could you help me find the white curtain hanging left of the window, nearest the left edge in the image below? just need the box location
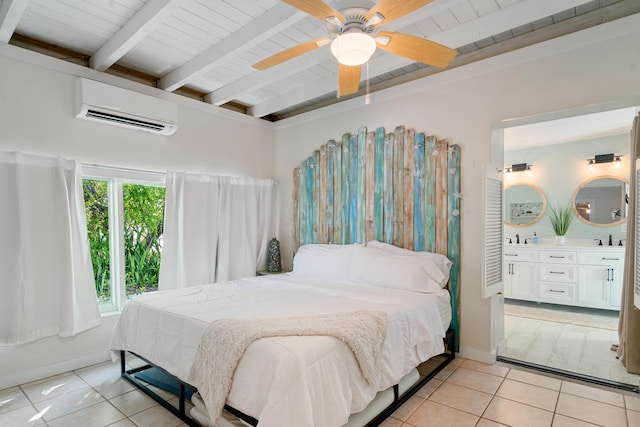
[0,152,100,345]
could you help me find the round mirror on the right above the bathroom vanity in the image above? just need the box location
[573,176,629,226]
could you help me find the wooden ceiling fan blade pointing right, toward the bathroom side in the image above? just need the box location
[377,31,458,68]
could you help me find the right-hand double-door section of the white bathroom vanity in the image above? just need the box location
[578,249,624,310]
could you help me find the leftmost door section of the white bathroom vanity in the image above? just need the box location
[503,248,538,301]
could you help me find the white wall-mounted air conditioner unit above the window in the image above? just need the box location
[75,77,178,135]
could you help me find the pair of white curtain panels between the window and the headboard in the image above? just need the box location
[158,172,273,290]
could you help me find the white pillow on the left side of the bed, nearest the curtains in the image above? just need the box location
[292,244,363,282]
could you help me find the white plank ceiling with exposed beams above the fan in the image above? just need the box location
[0,0,640,120]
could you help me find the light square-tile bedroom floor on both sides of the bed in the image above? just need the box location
[0,358,640,427]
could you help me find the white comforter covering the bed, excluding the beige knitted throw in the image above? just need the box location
[111,274,451,427]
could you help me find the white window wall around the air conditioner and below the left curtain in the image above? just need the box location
[0,44,277,389]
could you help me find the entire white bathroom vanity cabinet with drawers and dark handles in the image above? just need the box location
[503,245,624,310]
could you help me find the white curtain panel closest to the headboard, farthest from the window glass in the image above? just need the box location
[216,178,273,282]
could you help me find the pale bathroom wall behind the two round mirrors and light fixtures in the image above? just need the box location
[504,133,631,244]
